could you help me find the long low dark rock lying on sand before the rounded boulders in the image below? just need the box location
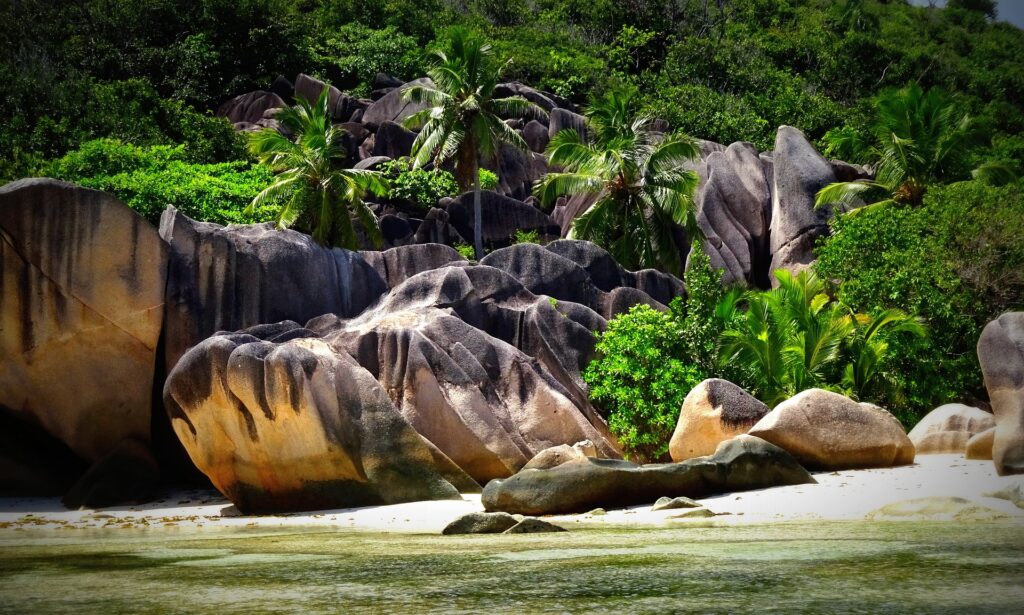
[482,436,814,515]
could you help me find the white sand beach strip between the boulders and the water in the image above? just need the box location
[0,454,1024,538]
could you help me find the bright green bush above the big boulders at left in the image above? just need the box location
[44,139,276,224]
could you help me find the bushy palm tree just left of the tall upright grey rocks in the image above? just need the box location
[535,88,699,273]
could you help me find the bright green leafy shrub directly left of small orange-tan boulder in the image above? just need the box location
[584,304,708,460]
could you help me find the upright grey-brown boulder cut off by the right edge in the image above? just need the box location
[978,312,1024,475]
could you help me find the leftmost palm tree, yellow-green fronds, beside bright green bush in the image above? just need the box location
[246,88,388,250]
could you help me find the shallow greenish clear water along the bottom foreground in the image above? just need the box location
[0,522,1024,615]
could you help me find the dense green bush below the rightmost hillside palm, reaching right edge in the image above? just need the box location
[815,181,1024,414]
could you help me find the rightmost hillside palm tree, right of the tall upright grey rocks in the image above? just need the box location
[815,84,1006,211]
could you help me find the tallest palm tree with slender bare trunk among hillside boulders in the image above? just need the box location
[403,28,545,259]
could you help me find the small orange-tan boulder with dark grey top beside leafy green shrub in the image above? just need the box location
[669,378,770,462]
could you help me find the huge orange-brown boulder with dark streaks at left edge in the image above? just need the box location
[0,179,167,463]
